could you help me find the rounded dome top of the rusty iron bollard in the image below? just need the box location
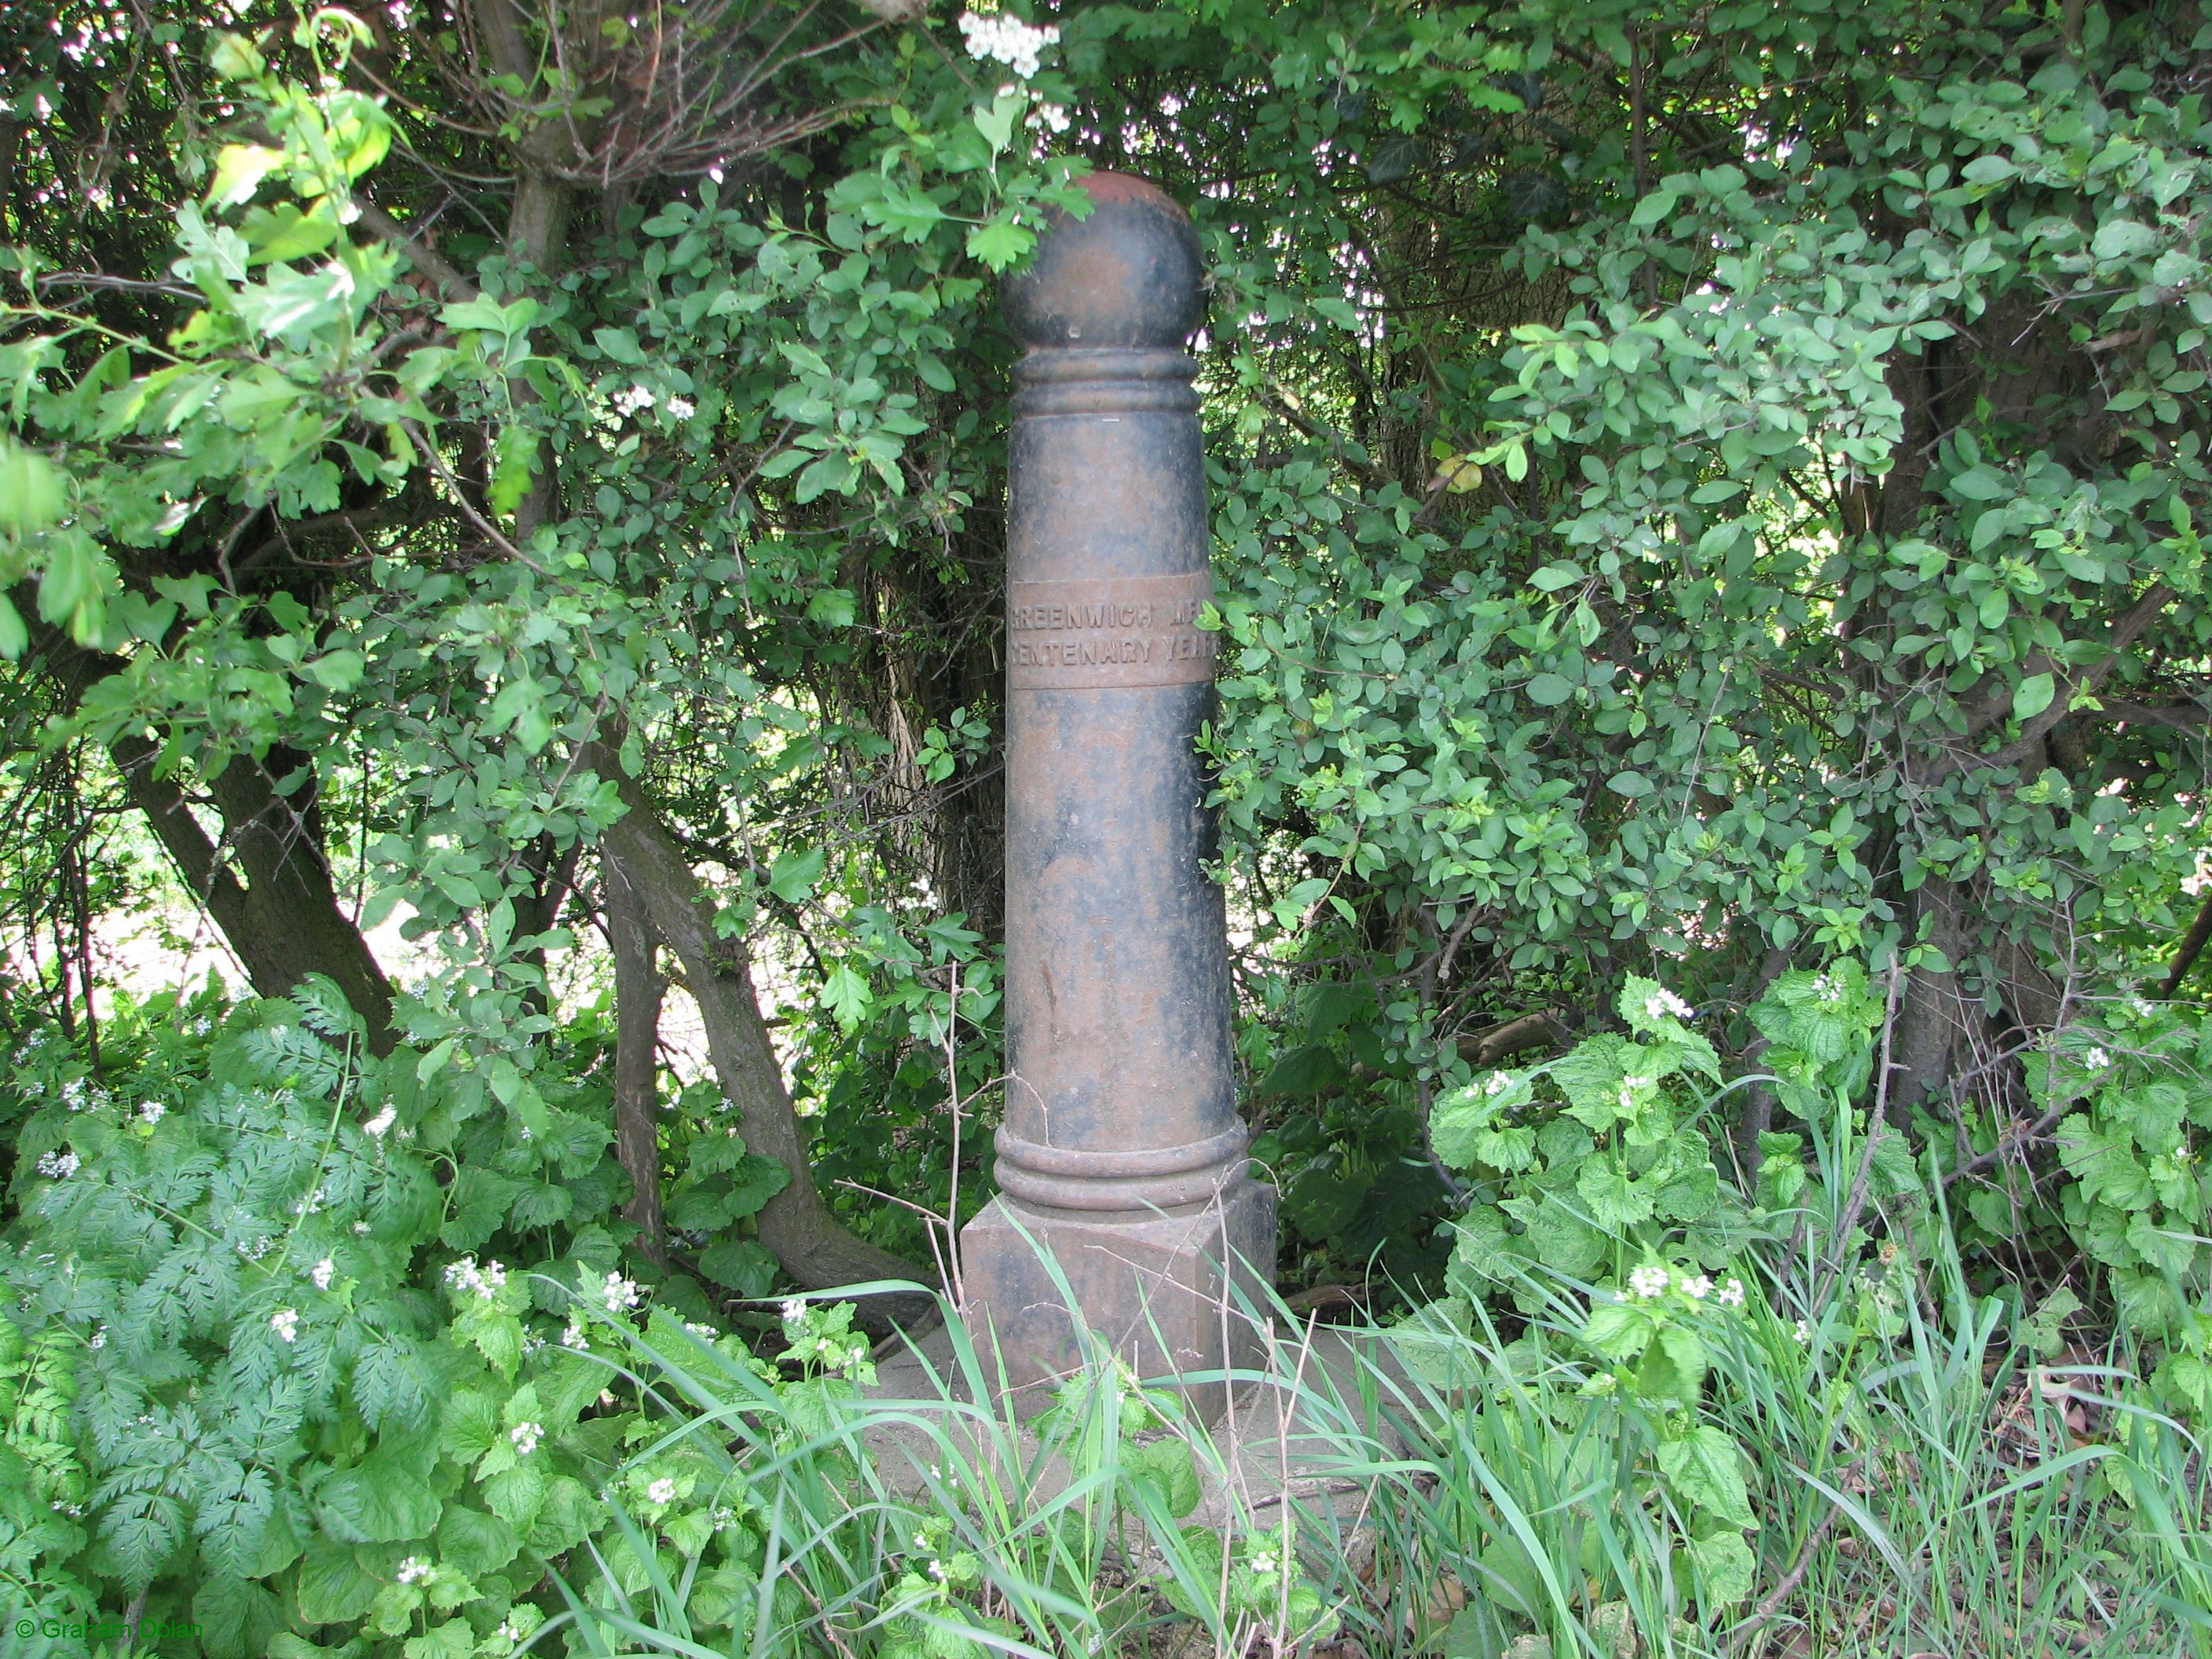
[1006,173,1206,350]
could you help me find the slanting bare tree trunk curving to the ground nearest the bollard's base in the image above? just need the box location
[580,743,936,1320]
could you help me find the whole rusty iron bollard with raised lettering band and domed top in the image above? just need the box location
[960,173,1274,1387]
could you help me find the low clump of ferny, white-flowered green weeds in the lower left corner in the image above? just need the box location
[0,984,781,1659]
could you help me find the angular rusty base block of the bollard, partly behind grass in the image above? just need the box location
[960,1177,1274,1418]
